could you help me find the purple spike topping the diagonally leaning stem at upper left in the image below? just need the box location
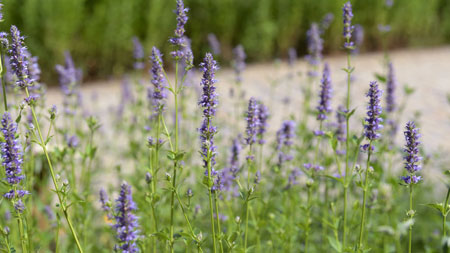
[9,25,34,88]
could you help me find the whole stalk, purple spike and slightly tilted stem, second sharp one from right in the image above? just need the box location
[356,81,383,249]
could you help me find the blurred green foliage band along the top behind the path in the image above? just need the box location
[1,0,450,83]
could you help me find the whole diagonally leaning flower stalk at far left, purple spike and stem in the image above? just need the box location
[9,26,83,252]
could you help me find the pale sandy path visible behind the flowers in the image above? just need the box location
[48,47,450,152]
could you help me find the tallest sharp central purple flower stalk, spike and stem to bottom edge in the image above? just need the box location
[198,53,220,252]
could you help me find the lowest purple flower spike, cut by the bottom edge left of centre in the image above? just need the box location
[114,182,139,253]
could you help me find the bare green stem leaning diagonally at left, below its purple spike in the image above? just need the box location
[25,87,84,253]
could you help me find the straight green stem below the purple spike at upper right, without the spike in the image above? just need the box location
[342,49,351,249]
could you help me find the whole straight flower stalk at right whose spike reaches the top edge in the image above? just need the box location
[342,1,354,249]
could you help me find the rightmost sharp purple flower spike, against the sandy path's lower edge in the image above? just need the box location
[402,121,422,184]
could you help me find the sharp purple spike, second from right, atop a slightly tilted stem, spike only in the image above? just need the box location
[364,81,383,141]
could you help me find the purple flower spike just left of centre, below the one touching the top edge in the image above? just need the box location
[151,47,166,112]
